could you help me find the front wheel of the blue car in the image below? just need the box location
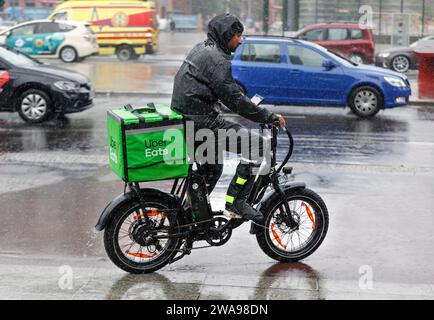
[349,86,383,118]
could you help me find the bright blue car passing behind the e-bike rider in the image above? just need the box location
[232,36,411,118]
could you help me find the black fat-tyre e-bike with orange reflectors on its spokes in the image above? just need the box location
[96,124,329,273]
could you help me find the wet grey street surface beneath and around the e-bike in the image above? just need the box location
[0,90,434,299]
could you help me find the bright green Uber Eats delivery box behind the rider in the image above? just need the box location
[107,103,189,182]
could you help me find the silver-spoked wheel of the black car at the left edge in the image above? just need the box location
[18,89,52,123]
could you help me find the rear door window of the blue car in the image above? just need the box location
[241,43,282,63]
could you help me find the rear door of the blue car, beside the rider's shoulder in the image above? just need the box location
[232,41,286,103]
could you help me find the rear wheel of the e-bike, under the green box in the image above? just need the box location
[104,198,181,274]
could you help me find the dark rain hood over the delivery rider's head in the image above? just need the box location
[208,13,244,54]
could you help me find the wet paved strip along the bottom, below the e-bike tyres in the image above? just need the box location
[0,258,434,300]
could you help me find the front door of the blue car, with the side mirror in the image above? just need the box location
[282,43,348,105]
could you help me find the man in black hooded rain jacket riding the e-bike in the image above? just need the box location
[171,13,285,224]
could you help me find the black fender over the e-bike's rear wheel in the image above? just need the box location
[95,188,178,231]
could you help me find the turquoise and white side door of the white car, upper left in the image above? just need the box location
[33,22,65,55]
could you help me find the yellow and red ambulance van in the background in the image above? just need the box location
[49,0,158,61]
